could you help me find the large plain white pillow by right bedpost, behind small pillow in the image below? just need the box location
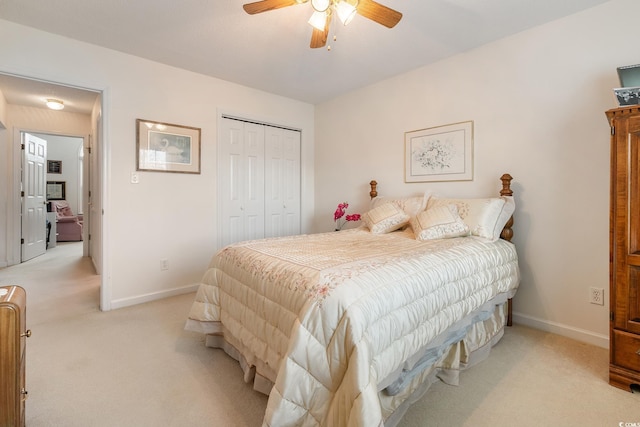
[427,197,515,241]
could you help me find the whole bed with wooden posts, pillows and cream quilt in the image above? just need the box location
[186,174,520,427]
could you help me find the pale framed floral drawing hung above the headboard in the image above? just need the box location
[404,121,473,182]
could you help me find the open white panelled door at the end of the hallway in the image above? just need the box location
[21,132,47,262]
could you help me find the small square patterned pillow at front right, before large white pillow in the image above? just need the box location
[411,205,469,241]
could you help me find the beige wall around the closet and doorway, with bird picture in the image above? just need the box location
[0,21,314,308]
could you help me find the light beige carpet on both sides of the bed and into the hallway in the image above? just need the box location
[0,244,640,427]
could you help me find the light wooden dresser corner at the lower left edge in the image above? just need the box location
[0,286,31,427]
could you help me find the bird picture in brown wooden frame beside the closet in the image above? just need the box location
[136,119,201,174]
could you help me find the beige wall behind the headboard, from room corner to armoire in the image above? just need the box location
[315,0,640,346]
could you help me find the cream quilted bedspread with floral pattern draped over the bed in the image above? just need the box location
[189,228,519,427]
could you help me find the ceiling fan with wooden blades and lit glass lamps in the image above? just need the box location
[242,0,402,48]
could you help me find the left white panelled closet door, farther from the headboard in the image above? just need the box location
[218,118,264,247]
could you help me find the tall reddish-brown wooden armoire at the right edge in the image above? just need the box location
[606,105,640,391]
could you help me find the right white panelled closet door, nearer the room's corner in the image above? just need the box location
[265,126,300,237]
